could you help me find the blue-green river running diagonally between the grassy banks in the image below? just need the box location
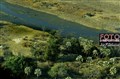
[0,2,107,40]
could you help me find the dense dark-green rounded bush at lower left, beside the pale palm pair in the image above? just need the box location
[3,56,26,75]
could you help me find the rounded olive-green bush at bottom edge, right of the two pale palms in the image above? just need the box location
[48,63,68,77]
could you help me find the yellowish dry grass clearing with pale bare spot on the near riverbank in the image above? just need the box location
[0,21,49,56]
